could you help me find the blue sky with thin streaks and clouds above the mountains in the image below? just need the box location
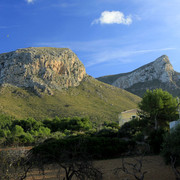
[0,0,180,77]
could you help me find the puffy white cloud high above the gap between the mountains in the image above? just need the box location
[92,11,132,25]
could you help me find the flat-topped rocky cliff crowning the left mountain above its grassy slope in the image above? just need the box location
[0,47,86,94]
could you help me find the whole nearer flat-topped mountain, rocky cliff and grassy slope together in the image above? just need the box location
[0,48,140,121]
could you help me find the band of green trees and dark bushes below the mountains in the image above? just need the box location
[0,89,180,180]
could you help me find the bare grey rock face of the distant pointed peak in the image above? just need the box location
[112,55,174,89]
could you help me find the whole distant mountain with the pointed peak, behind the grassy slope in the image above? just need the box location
[97,55,180,96]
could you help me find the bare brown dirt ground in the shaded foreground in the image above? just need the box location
[26,156,175,180]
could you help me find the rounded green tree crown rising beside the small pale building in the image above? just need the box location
[139,89,178,129]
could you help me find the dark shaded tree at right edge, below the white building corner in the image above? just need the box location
[162,126,180,180]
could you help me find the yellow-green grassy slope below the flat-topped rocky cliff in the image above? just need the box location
[0,76,140,122]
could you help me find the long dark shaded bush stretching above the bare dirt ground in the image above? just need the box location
[34,137,135,159]
